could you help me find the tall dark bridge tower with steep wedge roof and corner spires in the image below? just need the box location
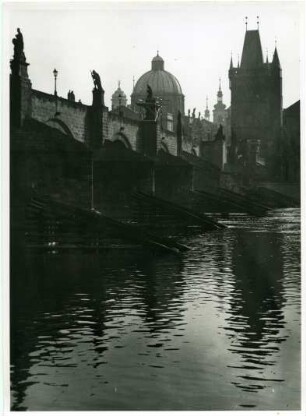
[229,23,282,171]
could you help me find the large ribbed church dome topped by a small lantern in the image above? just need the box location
[133,54,183,97]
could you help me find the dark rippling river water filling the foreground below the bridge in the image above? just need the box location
[11,209,301,410]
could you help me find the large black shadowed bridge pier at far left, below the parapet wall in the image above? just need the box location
[10,119,90,216]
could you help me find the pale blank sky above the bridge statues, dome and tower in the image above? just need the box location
[5,1,303,114]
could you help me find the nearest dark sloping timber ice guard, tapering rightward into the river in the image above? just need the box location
[28,197,188,254]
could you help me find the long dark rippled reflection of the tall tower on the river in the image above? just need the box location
[225,231,285,391]
